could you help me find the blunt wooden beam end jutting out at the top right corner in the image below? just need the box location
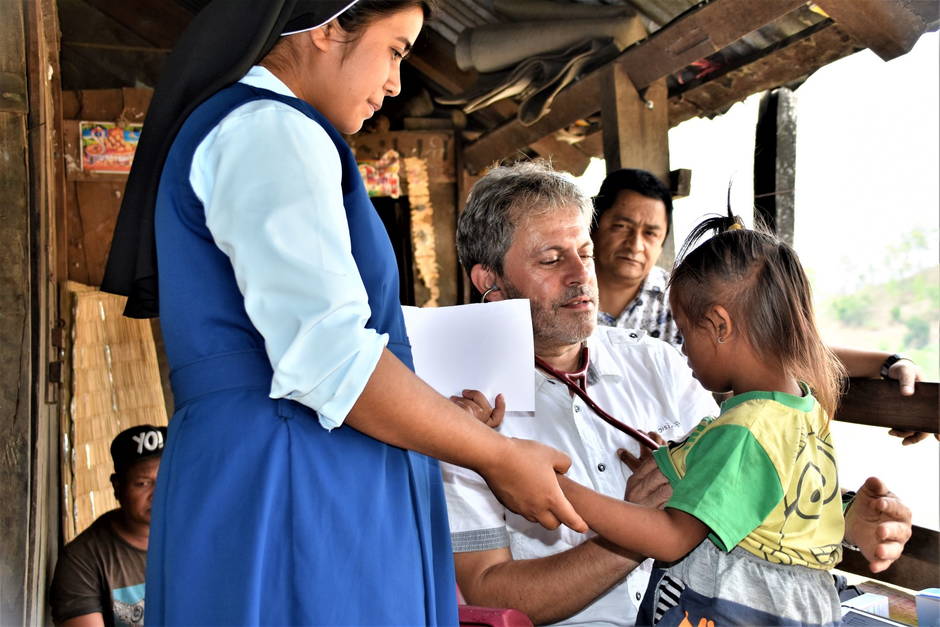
[816,0,927,61]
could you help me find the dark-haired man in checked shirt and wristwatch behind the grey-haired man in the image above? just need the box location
[591,168,926,444]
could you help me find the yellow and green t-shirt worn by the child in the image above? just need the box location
[654,384,845,569]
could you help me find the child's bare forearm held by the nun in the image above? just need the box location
[558,476,708,562]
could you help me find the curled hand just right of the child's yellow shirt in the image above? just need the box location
[845,477,911,573]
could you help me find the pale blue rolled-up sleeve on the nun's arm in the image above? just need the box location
[190,100,388,429]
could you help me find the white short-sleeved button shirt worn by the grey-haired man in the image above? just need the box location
[441,327,718,625]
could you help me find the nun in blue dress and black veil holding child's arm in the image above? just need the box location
[102,0,584,625]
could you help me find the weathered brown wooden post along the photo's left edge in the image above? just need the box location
[0,0,62,625]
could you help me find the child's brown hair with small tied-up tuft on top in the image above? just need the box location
[669,211,845,417]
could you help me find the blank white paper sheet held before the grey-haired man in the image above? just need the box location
[402,299,535,411]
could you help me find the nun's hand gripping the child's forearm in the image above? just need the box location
[478,438,588,533]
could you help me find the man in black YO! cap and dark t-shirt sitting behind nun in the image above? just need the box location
[50,425,166,627]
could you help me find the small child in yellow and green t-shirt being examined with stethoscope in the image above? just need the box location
[562,214,844,625]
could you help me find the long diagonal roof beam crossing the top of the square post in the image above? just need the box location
[465,0,805,172]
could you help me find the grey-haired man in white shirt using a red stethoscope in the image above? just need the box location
[442,163,910,625]
